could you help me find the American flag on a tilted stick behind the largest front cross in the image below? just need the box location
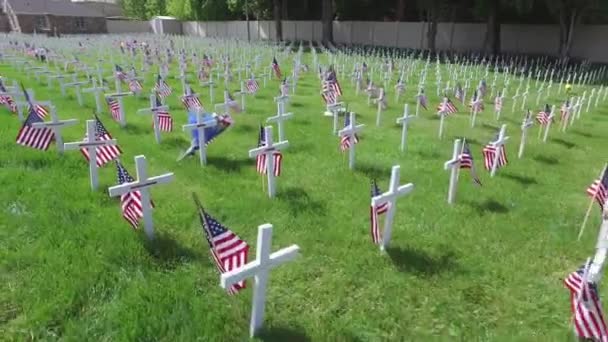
[194,196,249,295]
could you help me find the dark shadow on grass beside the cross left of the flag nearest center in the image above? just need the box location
[141,234,202,269]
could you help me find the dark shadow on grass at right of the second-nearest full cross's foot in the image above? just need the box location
[386,247,457,276]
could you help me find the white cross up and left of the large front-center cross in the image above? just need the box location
[108,155,174,240]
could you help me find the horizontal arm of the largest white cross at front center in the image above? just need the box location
[220,245,300,289]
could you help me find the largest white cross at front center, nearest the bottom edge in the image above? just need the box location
[220,223,300,337]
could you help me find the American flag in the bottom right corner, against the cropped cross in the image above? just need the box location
[564,262,608,342]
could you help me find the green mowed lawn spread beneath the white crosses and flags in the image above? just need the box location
[0,48,608,341]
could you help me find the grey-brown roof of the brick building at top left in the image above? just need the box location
[8,0,105,17]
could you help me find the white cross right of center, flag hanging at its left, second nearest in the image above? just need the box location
[372,165,414,250]
